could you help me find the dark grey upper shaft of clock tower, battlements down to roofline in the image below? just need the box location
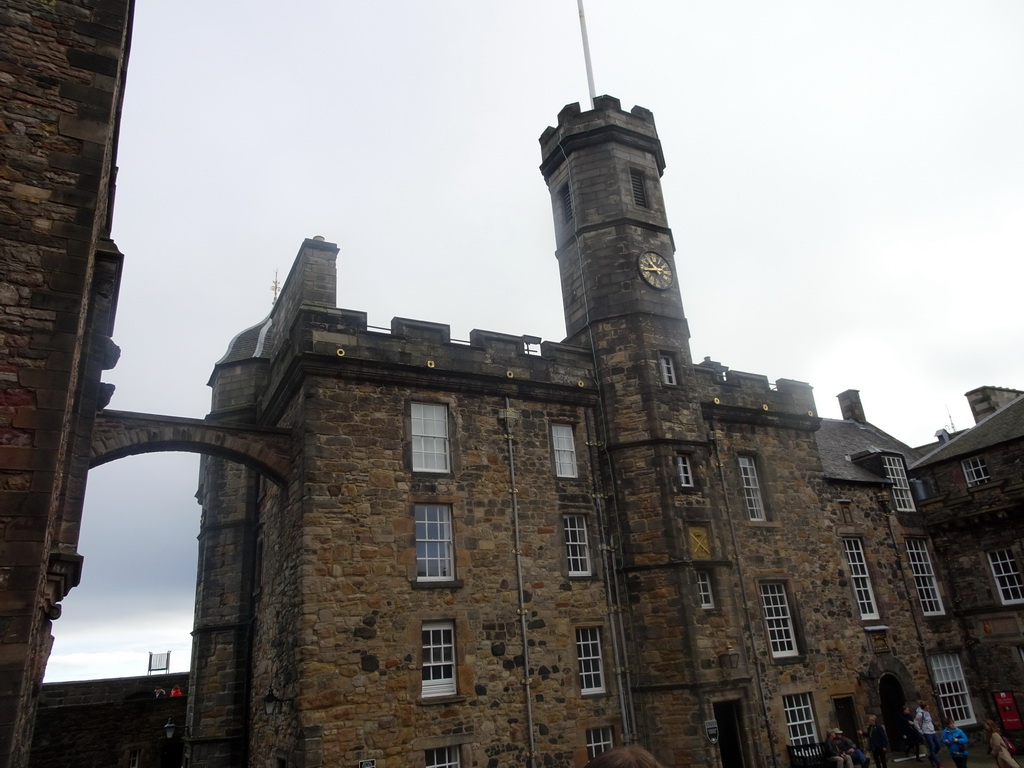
[541,96,689,346]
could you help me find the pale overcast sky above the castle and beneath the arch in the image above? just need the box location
[46,0,1024,681]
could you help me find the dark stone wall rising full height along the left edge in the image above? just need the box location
[0,0,131,766]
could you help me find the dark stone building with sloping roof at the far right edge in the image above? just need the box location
[911,387,1024,731]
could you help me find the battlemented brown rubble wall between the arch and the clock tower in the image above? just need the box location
[224,290,622,768]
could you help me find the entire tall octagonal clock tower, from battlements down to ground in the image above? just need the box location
[541,96,715,752]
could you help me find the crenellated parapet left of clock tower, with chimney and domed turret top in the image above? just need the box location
[210,239,597,421]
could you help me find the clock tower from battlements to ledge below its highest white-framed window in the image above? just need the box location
[541,96,705,448]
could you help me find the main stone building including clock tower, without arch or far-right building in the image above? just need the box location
[186,96,1024,768]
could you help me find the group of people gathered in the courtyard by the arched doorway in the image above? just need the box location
[825,701,1020,768]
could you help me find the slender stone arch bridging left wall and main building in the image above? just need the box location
[89,411,292,484]
